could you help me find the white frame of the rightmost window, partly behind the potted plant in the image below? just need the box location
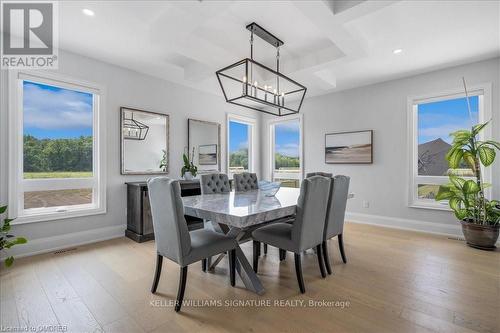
[407,83,492,211]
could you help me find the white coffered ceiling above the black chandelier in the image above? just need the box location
[59,0,500,96]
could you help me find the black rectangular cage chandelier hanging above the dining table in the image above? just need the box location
[216,22,307,116]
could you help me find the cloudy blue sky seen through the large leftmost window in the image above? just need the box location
[23,81,93,139]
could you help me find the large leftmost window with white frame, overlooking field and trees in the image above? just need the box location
[9,72,105,222]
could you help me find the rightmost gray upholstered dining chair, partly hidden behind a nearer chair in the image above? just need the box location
[322,175,350,274]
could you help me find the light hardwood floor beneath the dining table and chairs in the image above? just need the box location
[0,223,500,333]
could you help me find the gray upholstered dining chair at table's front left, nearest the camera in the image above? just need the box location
[148,177,237,312]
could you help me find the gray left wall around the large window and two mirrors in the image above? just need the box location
[0,51,260,246]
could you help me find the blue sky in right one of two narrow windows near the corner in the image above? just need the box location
[274,120,300,157]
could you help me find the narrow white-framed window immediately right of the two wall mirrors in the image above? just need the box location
[227,115,255,178]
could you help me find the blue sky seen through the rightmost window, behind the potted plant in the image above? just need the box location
[418,96,479,144]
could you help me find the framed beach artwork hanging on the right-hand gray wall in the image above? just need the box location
[325,130,373,164]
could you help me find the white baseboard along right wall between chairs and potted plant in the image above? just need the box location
[346,213,463,237]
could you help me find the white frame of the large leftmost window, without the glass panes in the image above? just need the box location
[8,71,106,224]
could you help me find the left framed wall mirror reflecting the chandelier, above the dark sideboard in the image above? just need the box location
[120,107,170,175]
